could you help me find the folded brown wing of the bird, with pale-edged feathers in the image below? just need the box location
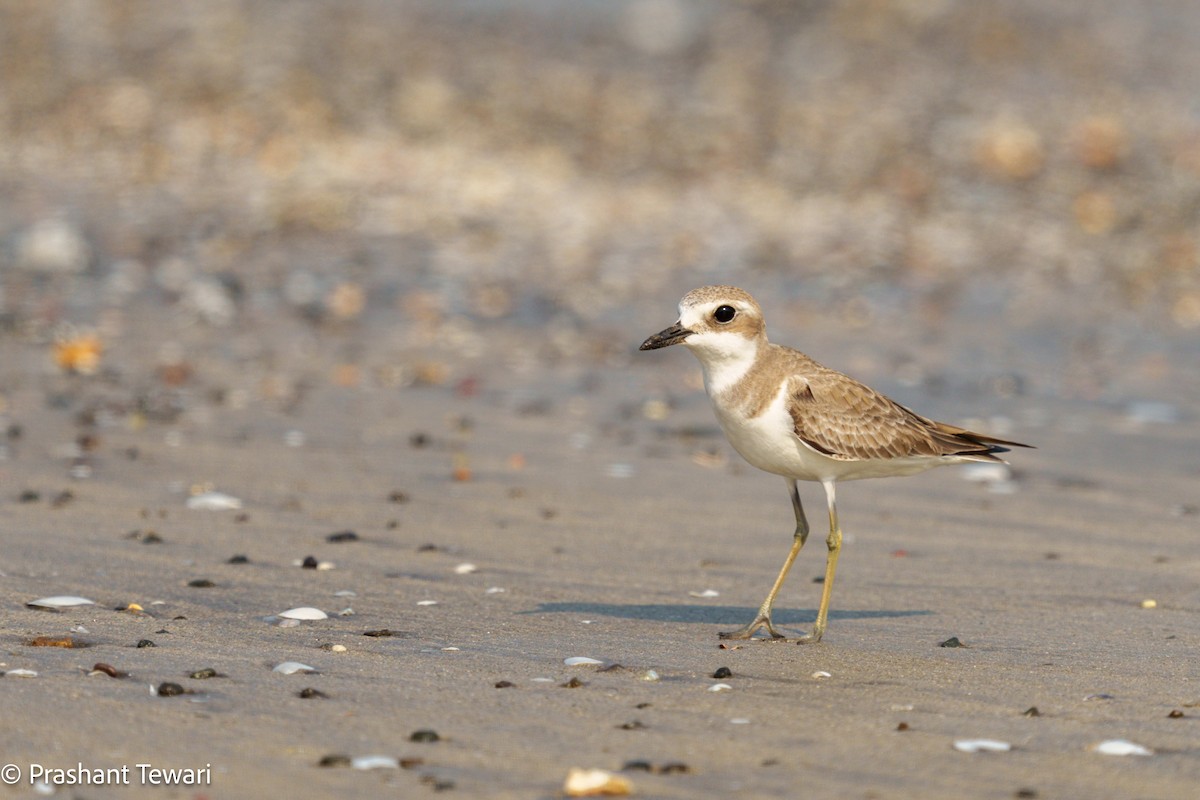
[791,367,1027,461]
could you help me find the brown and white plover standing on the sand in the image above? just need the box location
[640,287,1030,642]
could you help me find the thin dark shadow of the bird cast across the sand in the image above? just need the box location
[518,602,932,625]
